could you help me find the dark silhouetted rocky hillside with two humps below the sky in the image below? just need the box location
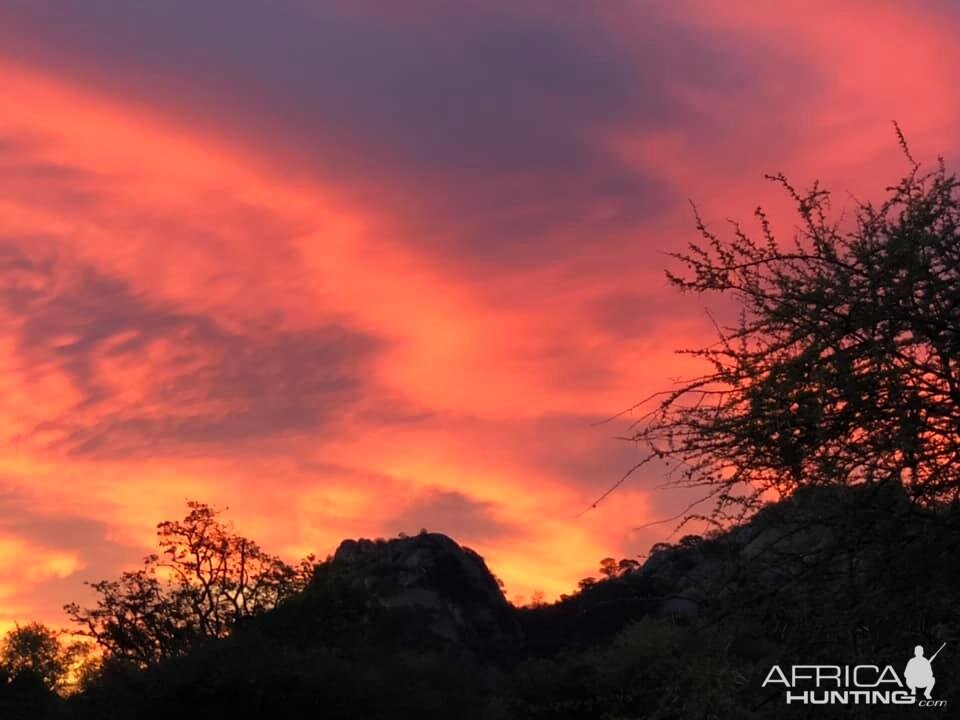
[9,488,960,720]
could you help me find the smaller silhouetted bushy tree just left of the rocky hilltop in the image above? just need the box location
[65,502,314,666]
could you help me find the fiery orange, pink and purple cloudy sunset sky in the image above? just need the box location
[0,0,960,630]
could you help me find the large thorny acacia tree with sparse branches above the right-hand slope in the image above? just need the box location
[620,128,960,521]
